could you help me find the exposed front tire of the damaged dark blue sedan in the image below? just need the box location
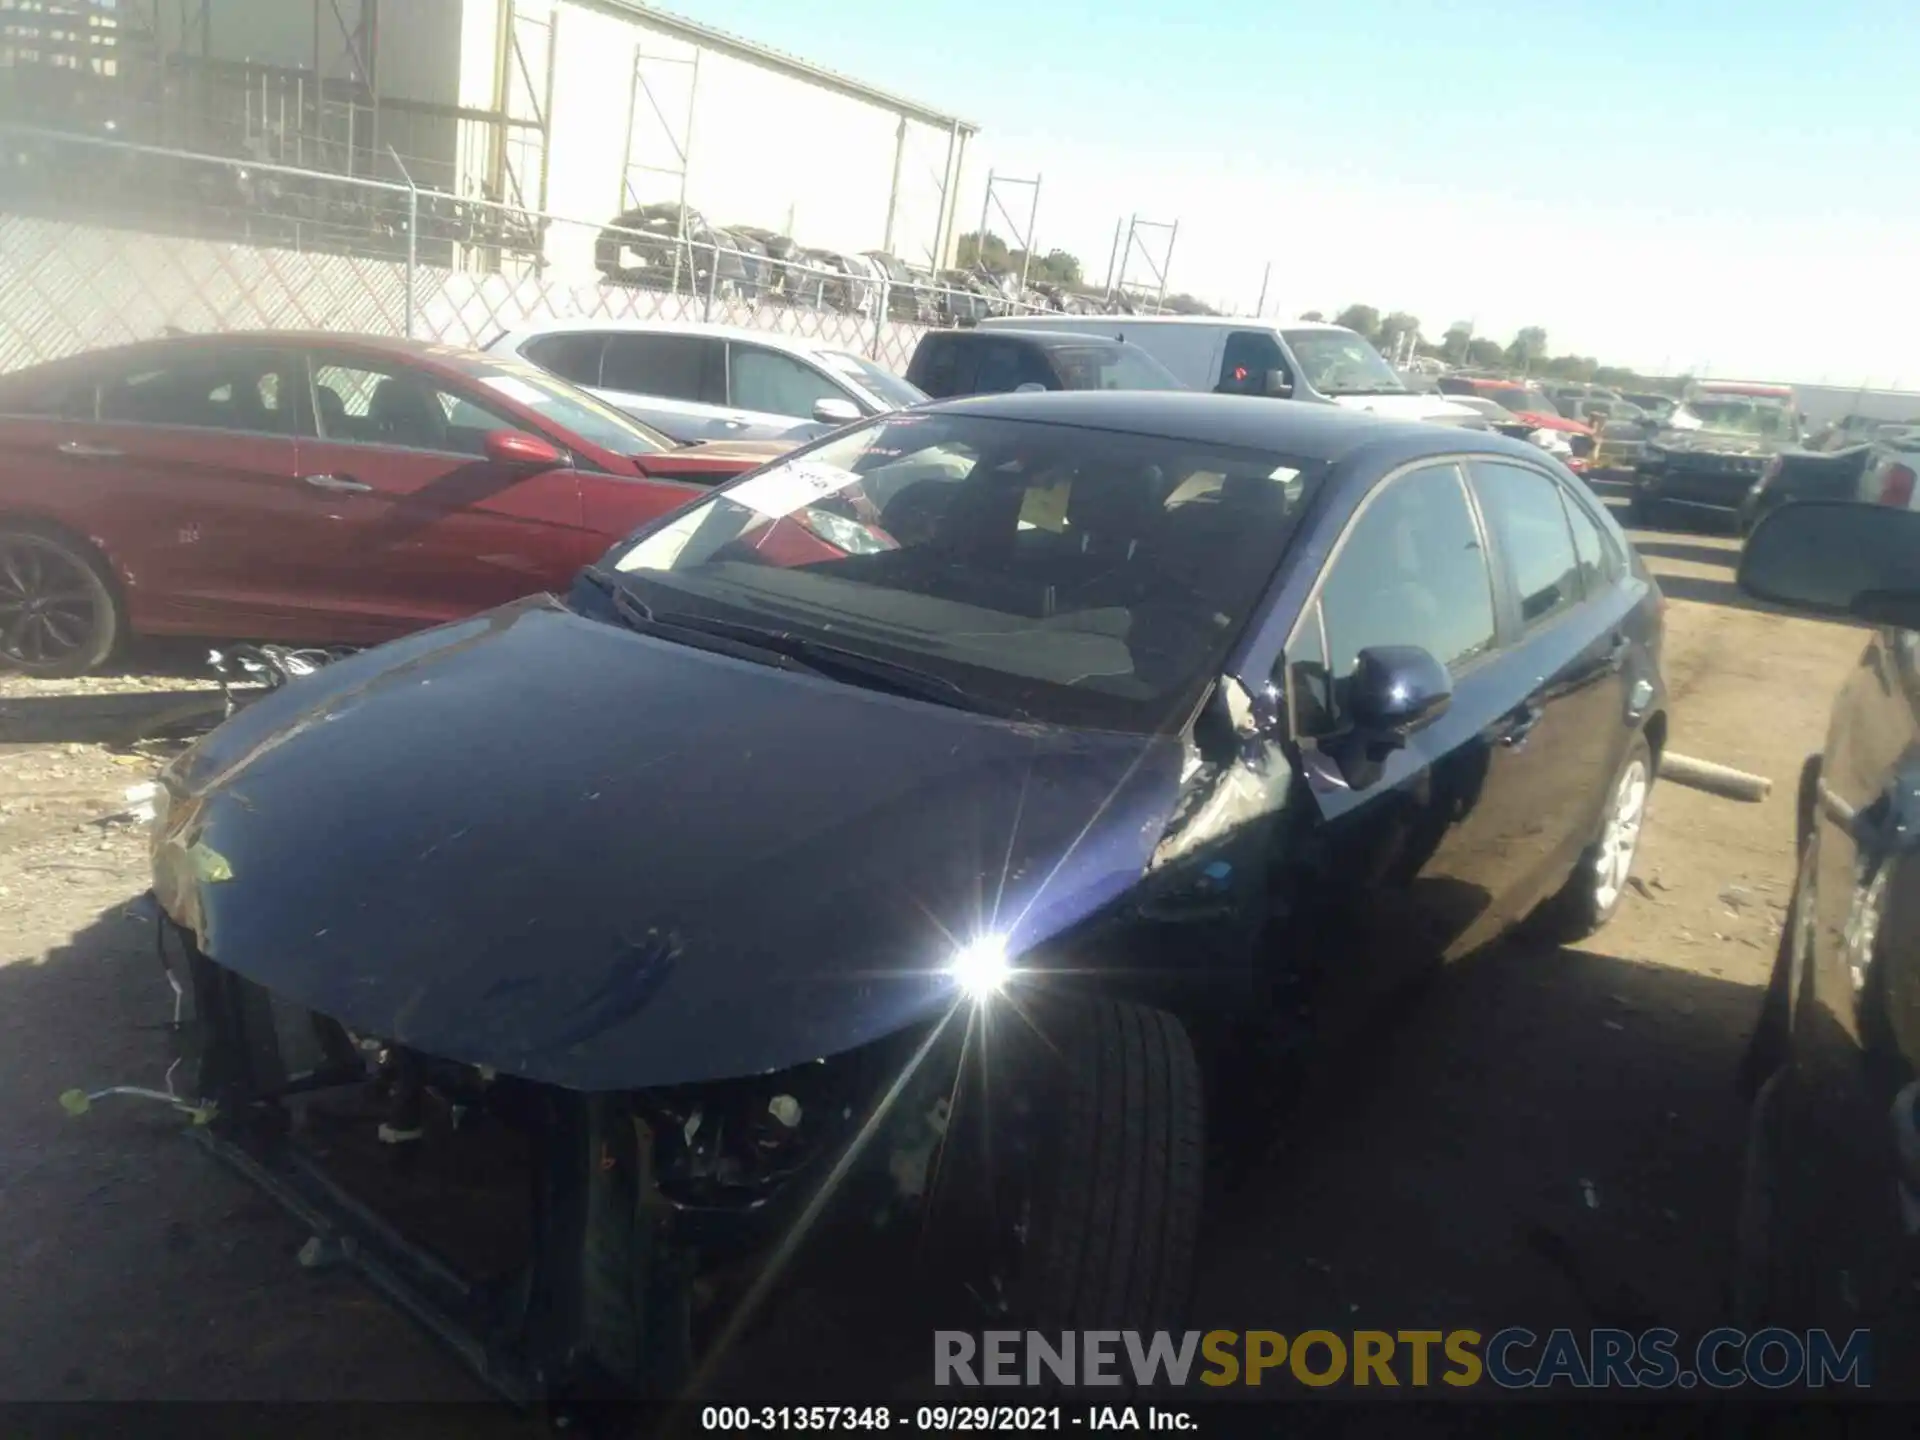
[933,998,1206,1332]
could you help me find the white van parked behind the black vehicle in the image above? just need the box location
[979,315,1488,430]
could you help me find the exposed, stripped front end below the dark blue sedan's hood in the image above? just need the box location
[114,914,964,1407]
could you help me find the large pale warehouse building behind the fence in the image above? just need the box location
[0,0,977,267]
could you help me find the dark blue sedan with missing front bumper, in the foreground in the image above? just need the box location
[142,394,1667,1398]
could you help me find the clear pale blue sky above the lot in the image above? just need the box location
[662,0,1920,386]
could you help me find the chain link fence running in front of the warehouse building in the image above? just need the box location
[0,127,1136,380]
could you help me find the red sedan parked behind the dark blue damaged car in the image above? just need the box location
[0,332,789,676]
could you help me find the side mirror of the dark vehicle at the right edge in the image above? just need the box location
[1740,499,1920,630]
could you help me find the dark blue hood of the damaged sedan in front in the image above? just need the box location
[154,597,1181,1091]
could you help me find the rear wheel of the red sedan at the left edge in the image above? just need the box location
[0,520,127,680]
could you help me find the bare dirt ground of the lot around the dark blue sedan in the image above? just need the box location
[0,499,1862,1400]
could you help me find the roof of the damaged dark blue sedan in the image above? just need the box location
[914,390,1542,463]
